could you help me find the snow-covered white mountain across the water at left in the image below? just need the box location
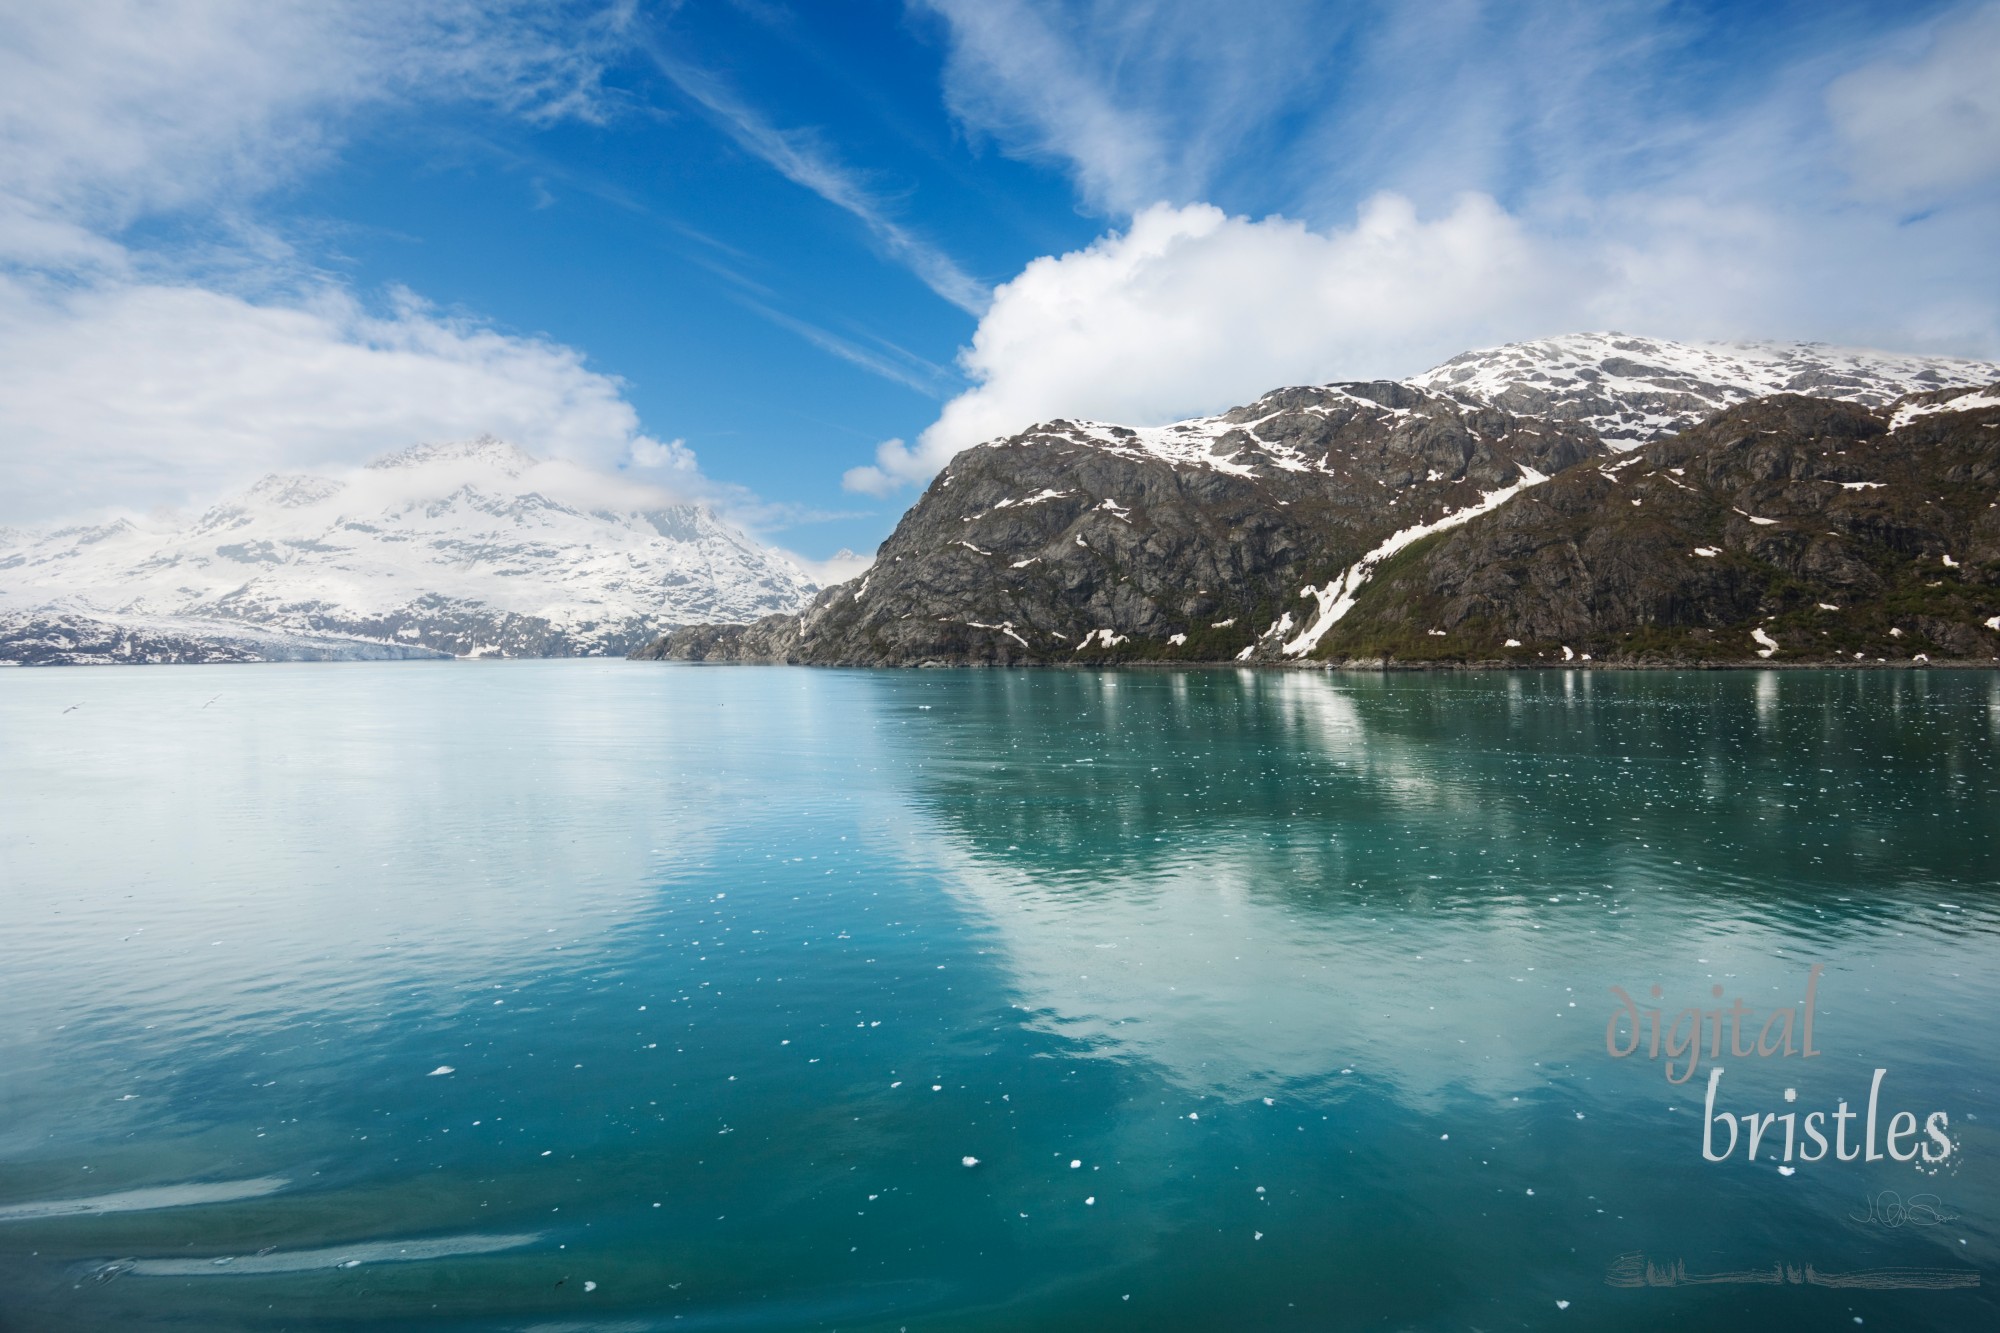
[0,438,816,660]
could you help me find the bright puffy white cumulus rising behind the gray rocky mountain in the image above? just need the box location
[846,196,1548,494]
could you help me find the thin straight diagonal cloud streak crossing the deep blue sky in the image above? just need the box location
[642,38,992,314]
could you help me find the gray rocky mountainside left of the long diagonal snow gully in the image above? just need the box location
[636,382,1604,667]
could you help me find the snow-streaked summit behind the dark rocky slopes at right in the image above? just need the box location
[1410,332,2000,448]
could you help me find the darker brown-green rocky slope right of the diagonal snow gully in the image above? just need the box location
[1318,390,2000,664]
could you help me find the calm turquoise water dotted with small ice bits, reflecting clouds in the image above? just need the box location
[0,662,2000,1333]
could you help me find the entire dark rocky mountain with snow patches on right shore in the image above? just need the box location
[638,338,2000,667]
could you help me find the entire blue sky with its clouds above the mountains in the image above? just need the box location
[0,0,2000,558]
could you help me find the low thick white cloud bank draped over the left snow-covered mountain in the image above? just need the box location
[0,278,692,522]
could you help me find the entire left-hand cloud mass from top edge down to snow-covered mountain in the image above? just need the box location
[0,0,680,522]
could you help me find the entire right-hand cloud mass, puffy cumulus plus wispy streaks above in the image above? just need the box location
[846,0,2000,494]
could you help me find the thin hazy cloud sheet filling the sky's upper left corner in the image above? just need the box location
[0,0,632,258]
